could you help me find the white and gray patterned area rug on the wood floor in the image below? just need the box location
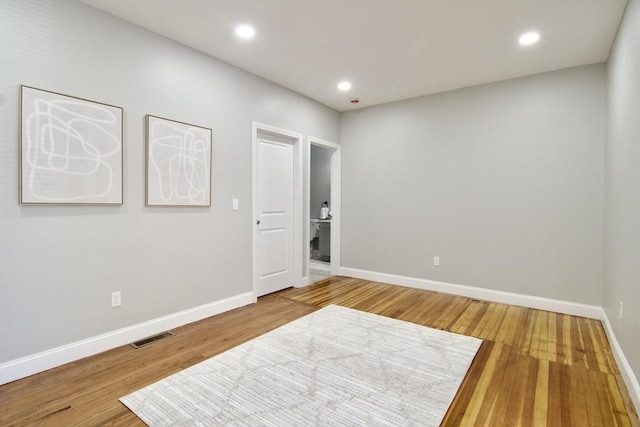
[120,305,482,427]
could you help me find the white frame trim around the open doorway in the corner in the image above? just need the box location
[304,136,342,283]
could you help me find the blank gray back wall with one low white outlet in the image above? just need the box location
[341,64,606,305]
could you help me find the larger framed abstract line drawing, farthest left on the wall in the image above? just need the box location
[20,86,123,204]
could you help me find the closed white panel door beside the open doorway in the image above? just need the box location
[256,138,294,296]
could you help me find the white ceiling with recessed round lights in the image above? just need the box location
[81,0,627,111]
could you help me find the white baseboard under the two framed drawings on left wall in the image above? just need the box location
[0,292,256,385]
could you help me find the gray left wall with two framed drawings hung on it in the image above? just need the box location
[0,0,339,362]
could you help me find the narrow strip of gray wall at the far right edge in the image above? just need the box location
[603,0,640,378]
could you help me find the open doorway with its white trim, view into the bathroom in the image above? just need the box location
[307,137,340,283]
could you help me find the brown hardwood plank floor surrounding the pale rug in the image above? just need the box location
[0,277,640,426]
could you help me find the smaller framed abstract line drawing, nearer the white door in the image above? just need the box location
[146,115,212,206]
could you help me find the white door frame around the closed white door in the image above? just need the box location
[251,121,308,301]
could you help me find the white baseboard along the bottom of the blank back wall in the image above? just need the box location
[340,267,602,319]
